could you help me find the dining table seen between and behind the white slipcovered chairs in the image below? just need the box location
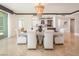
[20,31,61,45]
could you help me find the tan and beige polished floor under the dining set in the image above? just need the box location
[0,33,79,56]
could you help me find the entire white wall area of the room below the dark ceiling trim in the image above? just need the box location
[8,13,79,36]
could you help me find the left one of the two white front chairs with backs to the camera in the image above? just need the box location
[27,31,37,49]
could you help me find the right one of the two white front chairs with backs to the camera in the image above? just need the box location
[44,30,54,49]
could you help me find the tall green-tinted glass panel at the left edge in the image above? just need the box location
[0,11,8,39]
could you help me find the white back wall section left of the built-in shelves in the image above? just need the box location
[16,15,33,30]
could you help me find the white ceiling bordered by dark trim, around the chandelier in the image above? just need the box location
[1,3,79,13]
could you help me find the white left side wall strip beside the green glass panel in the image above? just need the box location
[8,13,16,37]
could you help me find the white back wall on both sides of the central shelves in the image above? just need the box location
[16,15,64,30]
